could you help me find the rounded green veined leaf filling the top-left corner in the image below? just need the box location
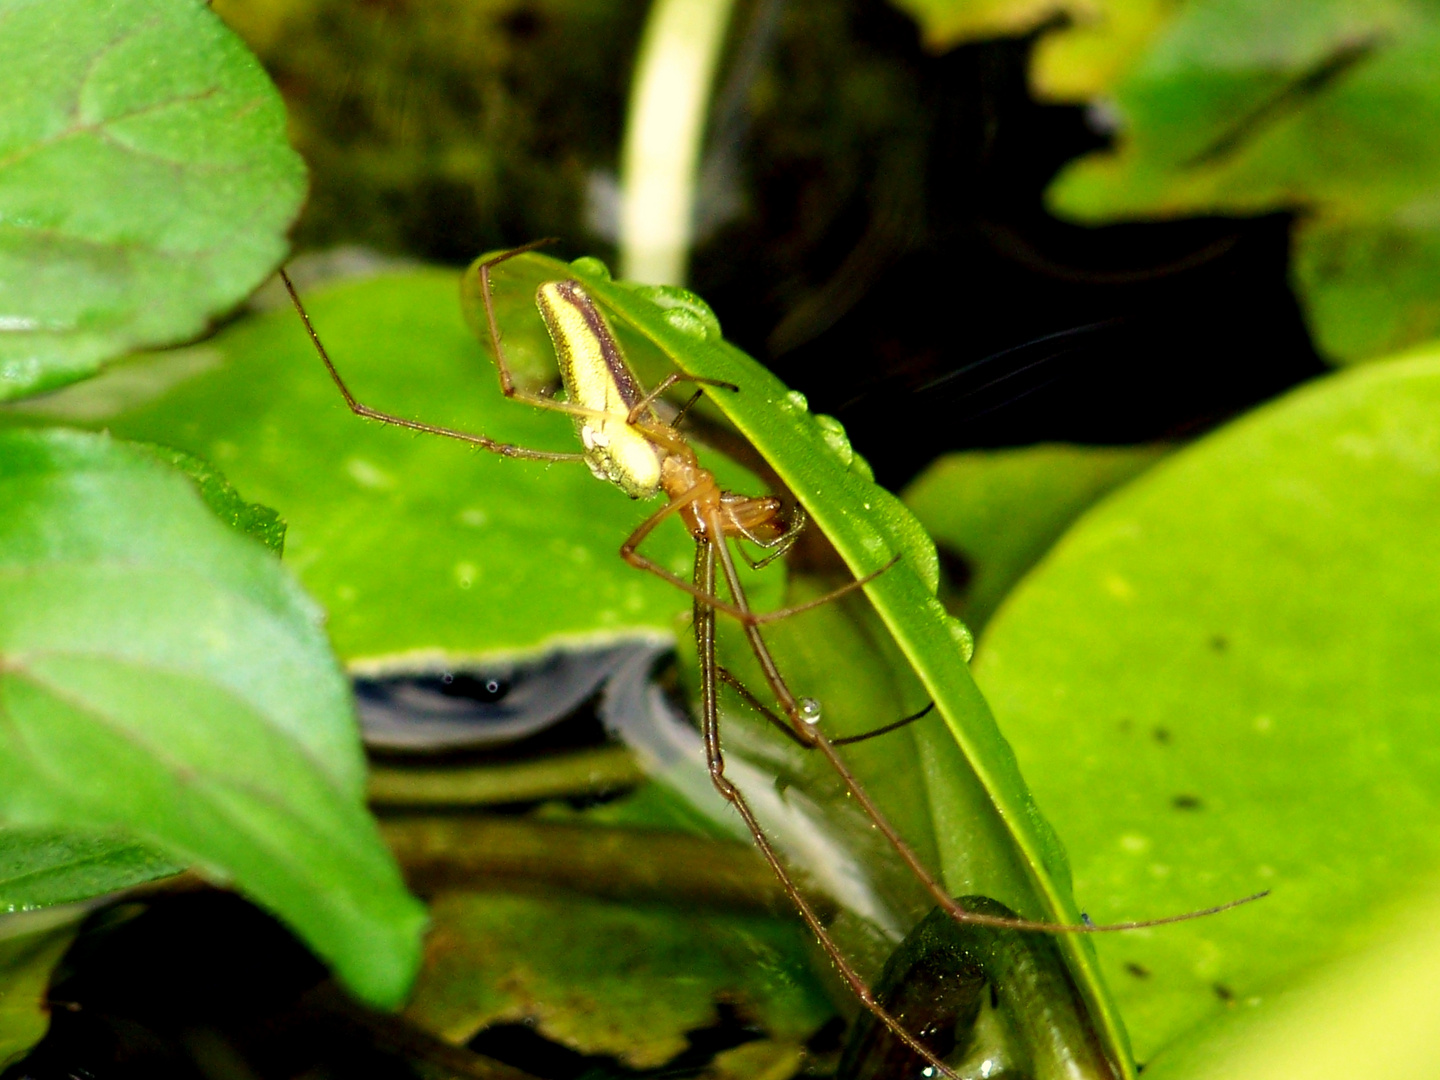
[0,0,305,400]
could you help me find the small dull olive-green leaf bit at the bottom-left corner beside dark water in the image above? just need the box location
[0,907,86,1068]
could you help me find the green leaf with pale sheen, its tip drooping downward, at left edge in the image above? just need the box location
[0,431,423,1004]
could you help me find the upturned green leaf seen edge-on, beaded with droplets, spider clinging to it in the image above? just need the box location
[463,255,1130,1071]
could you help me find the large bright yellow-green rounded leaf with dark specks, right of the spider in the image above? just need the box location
[976,351,1440,1060]
